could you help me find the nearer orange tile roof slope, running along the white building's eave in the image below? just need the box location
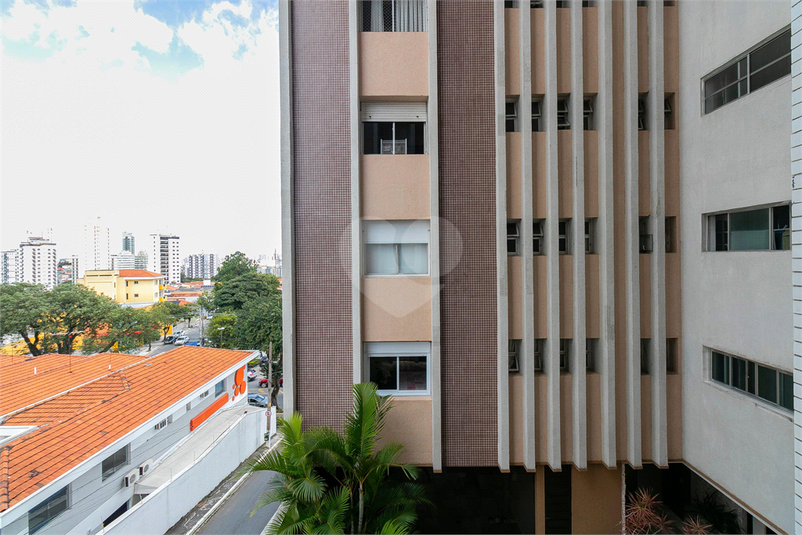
[0,346,251,511]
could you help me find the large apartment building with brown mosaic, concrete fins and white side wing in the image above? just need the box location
[279,0,802,533]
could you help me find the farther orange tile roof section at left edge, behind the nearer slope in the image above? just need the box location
[0,353,147,416]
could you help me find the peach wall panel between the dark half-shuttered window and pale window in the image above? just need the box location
[360,154,431,219]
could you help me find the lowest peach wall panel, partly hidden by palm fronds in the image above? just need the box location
[379,396,432,466]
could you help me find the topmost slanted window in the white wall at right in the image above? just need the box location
[702,28,791,114]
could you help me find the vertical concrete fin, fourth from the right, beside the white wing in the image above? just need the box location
[570,0,588,470]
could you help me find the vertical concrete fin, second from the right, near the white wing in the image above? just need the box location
[623,0,641,468]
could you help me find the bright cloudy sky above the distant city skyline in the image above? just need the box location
[0,0,281,258]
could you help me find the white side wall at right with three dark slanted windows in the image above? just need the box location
[678,0,794,531]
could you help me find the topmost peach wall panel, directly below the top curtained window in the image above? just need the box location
[358,32,429,100]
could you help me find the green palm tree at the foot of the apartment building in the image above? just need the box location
[246,383,429,534]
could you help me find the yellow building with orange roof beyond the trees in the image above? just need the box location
[78,269,164,308]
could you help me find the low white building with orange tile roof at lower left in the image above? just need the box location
[0,347,266,535]
